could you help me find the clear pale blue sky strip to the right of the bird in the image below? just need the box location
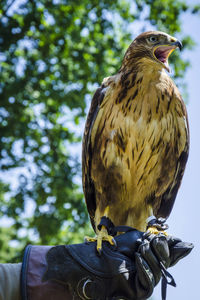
[153,5,200,300]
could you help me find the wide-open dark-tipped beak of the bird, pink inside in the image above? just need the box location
[153,40,183,72]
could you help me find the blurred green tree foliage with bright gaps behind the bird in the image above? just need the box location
[0,0,199,262]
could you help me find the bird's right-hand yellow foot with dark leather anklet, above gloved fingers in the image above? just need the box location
[147,217,168,236]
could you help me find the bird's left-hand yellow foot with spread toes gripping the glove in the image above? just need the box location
[85,206,116,254]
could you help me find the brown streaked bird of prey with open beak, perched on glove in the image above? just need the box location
[82,31,189,250]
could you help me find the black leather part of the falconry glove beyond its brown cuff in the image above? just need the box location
[43,230,193,300]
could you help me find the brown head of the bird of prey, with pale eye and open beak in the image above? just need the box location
[123,31,182,72]
